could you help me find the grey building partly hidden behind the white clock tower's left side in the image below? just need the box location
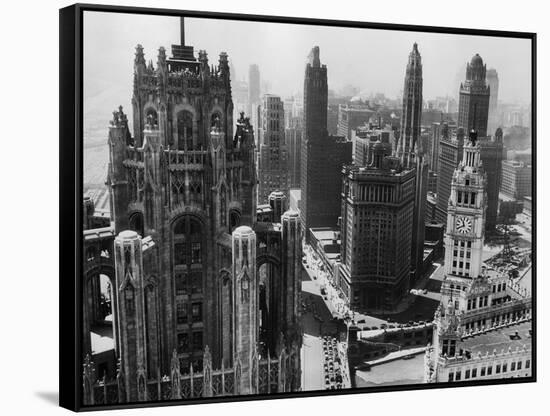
[435,128,464,224]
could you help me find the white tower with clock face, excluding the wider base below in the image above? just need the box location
[445,131,487,306]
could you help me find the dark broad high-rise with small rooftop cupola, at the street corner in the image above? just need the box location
[339,145,415,311]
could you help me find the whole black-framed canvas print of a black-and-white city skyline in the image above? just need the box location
[60,5,537,410]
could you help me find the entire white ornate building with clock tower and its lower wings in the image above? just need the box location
[424,131,532,383]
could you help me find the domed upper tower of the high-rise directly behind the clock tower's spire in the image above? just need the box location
[458,53,490,137]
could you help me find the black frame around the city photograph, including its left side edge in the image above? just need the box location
[59,4,537,411]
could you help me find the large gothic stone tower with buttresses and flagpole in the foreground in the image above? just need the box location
[83,22,302,404]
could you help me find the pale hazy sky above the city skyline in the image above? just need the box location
[84,12,531,118]
